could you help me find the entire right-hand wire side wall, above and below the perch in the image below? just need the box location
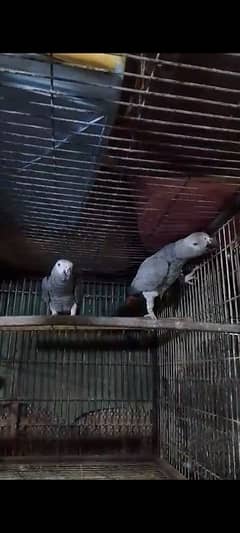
[159,217,240,479]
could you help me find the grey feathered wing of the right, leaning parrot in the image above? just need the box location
[131,256,169,292]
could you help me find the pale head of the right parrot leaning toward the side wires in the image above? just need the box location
[181,231,216,259]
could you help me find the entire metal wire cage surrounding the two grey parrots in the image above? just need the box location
[0,53,240,480]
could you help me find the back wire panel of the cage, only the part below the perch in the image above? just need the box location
[0,334,153,453]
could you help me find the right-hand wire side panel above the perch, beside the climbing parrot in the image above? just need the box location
[162,216,240,324]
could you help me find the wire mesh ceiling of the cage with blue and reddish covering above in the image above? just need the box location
[0,53,240,274]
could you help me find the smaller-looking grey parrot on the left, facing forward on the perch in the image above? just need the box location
[42,259,77,315]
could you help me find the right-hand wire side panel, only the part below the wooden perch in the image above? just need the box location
[160,333,240,479]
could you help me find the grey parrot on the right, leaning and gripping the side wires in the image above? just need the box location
[129,232,214,319]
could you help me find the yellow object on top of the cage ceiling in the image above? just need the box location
[51,54,125,73]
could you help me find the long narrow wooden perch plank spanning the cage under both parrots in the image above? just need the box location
[0,315,237,334]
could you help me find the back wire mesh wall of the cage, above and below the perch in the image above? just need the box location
[0,280,156,455]
